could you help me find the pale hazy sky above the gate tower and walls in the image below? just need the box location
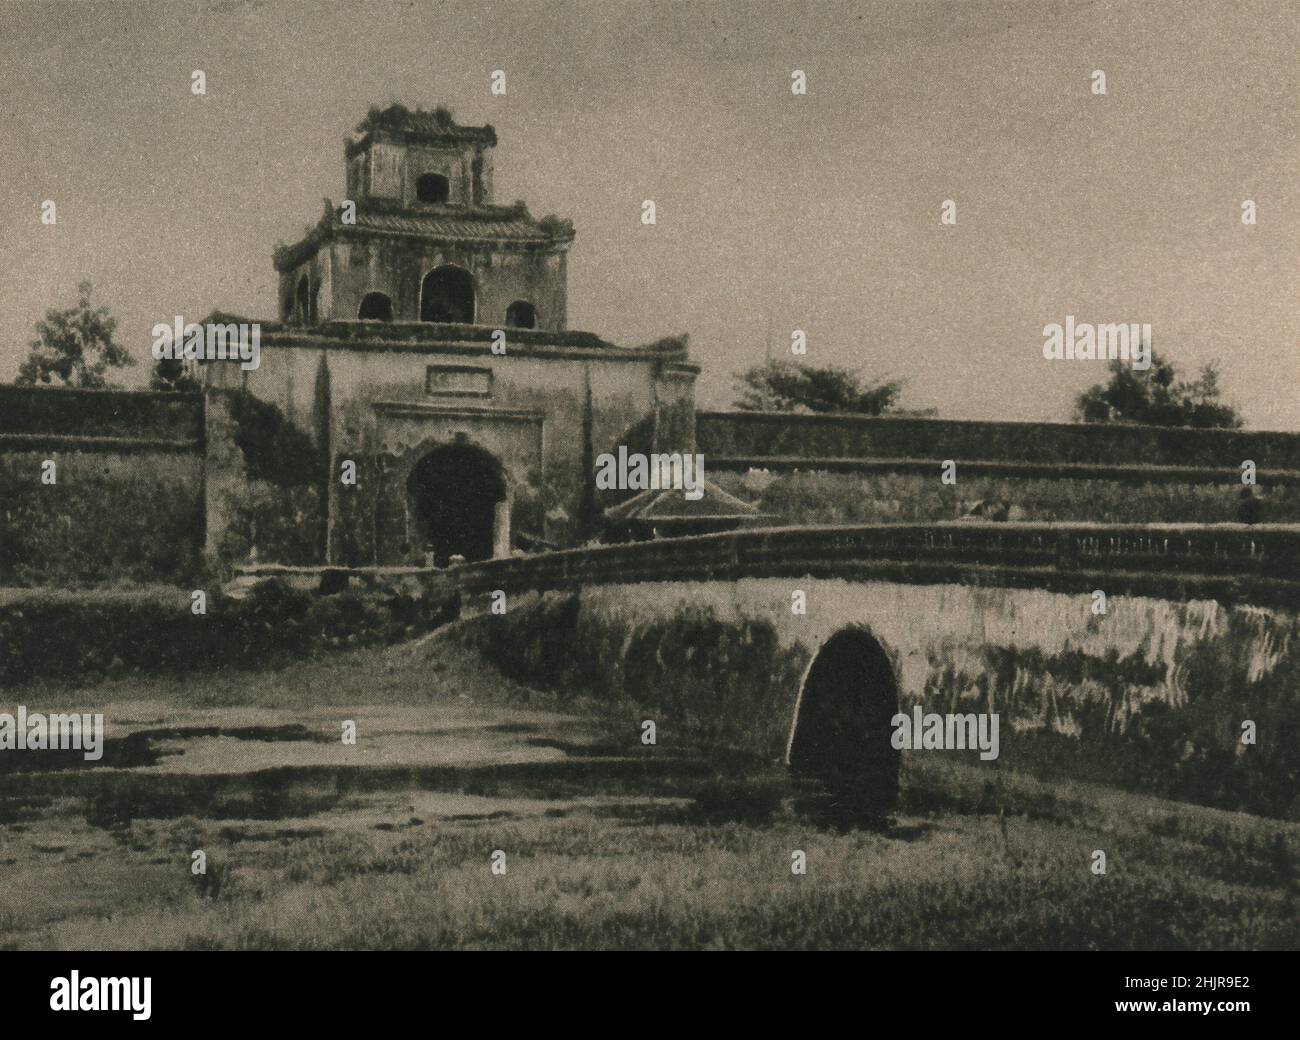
[0,0,1300,429]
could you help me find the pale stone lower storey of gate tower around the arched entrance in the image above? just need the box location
[212,329,696,566]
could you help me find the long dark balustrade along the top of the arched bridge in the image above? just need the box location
[450,521,1300,603]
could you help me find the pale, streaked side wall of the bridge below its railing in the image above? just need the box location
[465,579,1300,818]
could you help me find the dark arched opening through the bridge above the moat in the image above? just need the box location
[787,628,901,819]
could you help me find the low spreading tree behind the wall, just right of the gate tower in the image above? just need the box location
[735,361,902,415]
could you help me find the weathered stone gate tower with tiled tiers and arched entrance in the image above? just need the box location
[205,105,699,566]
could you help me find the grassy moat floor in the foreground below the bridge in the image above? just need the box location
[0,640,1300,949]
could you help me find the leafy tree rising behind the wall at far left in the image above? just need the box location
[14,282,135,387]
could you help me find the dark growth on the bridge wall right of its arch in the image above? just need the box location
[956,627,1300,820]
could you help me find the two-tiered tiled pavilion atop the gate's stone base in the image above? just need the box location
[274,104,573,332]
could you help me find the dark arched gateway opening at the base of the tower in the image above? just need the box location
[407,442,507,567]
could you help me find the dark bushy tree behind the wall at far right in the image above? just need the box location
[1075,351,1243,429]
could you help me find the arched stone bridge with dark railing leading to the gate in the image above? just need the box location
[248,521,1300,815]
